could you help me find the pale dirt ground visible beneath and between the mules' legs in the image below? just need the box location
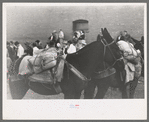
[7,77,144,99]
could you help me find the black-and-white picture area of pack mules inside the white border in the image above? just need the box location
[3,3,146,100]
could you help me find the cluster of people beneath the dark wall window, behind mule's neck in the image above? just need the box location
[45,29,87,54]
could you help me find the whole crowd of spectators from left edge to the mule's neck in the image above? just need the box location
[7,29,87,75]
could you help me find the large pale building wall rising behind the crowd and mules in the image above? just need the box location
[6,3,144,47]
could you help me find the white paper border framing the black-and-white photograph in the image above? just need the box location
[2,3,147,120]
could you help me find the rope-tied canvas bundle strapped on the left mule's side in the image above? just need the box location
[28,48,57,84]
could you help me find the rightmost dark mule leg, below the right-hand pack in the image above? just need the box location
[129,78,138,98]
